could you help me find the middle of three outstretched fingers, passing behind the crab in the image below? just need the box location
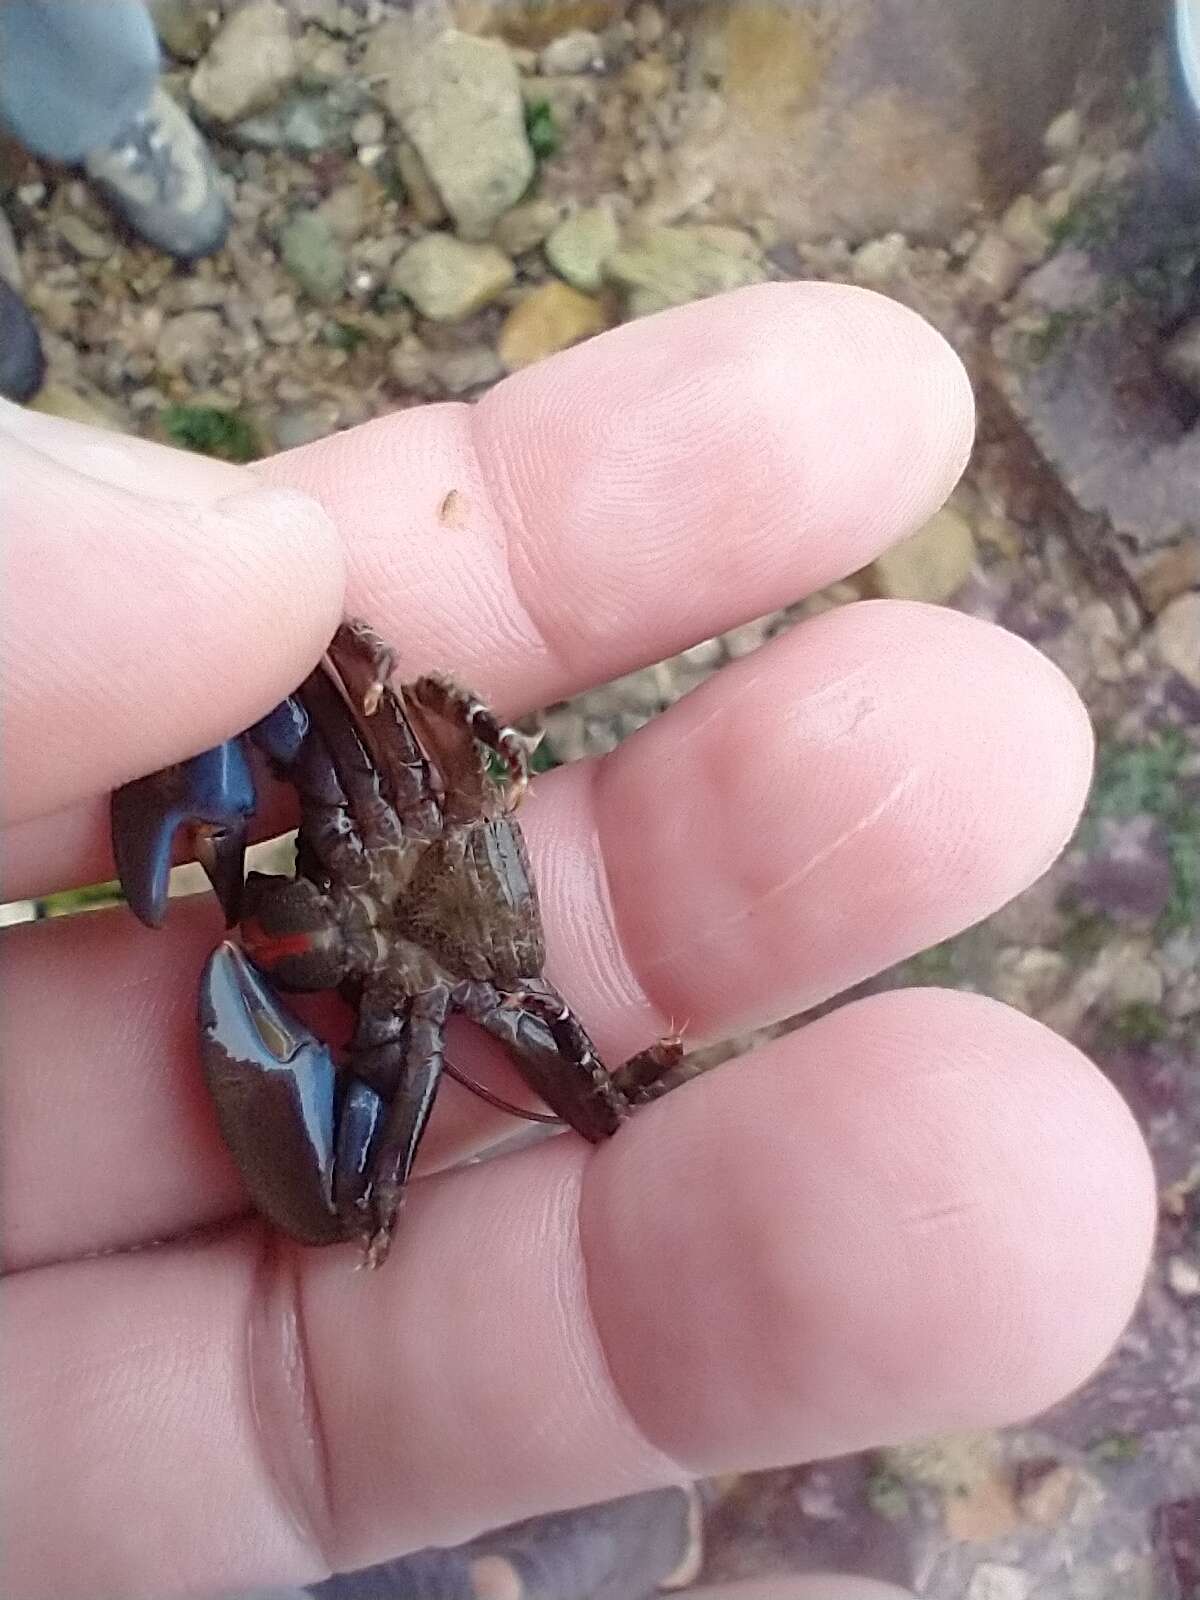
[3,602,1091,1266]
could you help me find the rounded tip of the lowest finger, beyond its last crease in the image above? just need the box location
[582,990,1155,1472]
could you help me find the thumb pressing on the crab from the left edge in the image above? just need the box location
[0,406,342,822]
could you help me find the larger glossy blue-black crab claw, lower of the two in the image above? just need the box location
[200,942,346,1245]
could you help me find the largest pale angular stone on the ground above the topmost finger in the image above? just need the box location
[366,18,534,240]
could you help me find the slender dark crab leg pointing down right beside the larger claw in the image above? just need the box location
[361,986,450,1267]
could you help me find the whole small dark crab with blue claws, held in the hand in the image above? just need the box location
[112,621,682,1266]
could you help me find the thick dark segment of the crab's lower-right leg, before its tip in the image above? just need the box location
[454,982,629,1144]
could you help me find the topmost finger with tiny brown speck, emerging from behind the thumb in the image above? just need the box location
[264,283,974,715]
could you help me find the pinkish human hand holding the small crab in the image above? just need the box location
[0,285,1154,1600]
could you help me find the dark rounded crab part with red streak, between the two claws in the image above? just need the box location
[242,872,346,990]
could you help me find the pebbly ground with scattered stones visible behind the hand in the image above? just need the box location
[0,0,1200,1600]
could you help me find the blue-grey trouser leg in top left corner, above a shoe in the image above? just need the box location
[0,0,160,162]
